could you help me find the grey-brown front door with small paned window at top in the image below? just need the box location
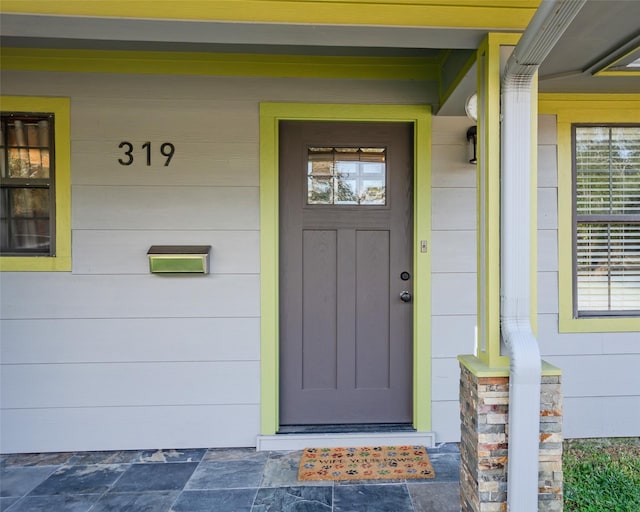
[279,121,413,425]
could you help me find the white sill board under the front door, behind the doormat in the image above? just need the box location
[256,432,436,452]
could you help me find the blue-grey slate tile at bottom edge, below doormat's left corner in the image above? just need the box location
[251,486,333,512]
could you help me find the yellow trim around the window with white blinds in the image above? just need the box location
[538,94,640,332]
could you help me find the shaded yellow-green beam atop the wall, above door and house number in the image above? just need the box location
[0,48,439,81]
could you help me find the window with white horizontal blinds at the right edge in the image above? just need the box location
[573,125,640,317]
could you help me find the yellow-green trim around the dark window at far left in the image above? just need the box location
[0,96,71,272]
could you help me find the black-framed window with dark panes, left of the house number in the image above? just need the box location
[0,112,55,256]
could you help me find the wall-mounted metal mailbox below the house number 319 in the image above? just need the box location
[147,245,211,274]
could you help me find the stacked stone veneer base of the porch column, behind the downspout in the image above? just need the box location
[458,356,563,512]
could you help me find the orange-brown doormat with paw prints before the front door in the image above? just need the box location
[298,446,436,480]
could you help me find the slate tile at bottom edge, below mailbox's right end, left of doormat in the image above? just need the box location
[171,489,257,512]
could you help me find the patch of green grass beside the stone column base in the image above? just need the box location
[563,438,640,512]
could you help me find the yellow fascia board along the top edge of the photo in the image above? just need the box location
[2,0,540,30]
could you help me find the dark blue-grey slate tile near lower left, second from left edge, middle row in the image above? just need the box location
[30,464,128,496]
